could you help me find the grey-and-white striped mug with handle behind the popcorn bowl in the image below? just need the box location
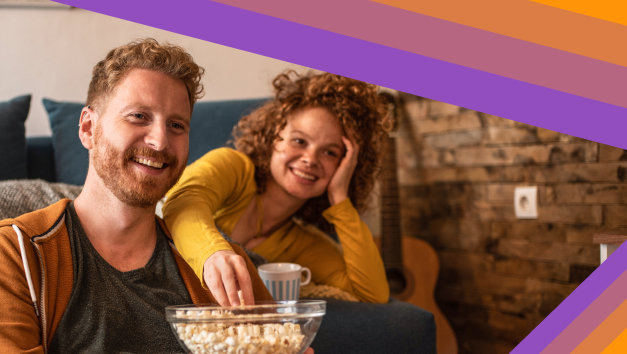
[257,263,311,301]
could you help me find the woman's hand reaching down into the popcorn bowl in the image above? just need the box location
[203,250,255,306]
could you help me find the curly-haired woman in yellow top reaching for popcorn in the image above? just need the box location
[163,73,391,306]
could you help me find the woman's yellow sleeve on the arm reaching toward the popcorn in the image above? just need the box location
[163,148,254,287]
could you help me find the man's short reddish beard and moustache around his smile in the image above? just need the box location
[90,128,187,208]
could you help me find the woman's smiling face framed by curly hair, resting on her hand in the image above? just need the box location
[268,108,346,202]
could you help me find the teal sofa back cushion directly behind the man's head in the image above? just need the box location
[43,98,266,185]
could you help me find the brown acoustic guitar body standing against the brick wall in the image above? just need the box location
[376,236,458,354]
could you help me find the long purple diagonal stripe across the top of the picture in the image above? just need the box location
[56,0,627,148]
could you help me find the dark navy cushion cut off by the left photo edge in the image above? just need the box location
[0,95,31,180]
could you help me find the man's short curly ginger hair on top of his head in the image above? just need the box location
[87,38,205,114]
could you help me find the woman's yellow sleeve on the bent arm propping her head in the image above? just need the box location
[322,198,390,303]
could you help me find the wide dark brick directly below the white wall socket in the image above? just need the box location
[490,220,567,242]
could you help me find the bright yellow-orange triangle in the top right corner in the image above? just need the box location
[531,0,627,25]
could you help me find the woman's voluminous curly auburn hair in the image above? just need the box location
[233,71,392,231]
